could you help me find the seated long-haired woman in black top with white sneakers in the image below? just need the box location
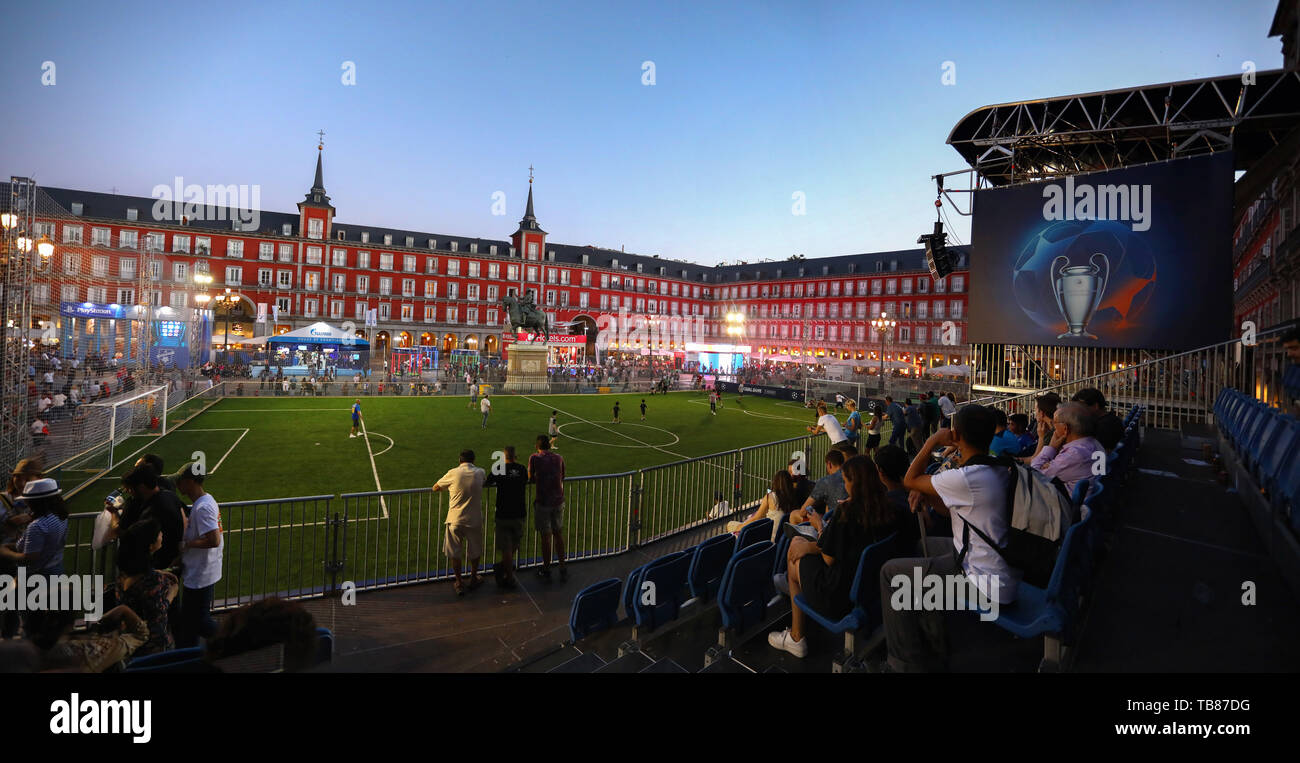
[767,456,907,656]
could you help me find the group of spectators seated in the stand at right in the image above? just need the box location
[727,387,1123,672]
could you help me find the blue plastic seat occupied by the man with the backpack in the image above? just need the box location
[995,507,1096,668]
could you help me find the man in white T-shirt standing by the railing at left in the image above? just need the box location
[174,463,225,647]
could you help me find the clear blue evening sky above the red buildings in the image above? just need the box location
[0,0,1282,264]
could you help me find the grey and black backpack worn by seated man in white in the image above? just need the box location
[957,455,1078,588]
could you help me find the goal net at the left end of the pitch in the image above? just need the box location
[43,386,168,493]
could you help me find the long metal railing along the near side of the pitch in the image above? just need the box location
[64,435,829,610]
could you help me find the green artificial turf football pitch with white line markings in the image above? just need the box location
[66,391,888,599]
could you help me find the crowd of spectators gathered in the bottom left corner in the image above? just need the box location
[0,454,317,672]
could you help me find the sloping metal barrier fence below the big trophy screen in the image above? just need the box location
[971,328,1287,429]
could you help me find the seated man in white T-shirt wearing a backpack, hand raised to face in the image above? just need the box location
[880,406,1021,672]
